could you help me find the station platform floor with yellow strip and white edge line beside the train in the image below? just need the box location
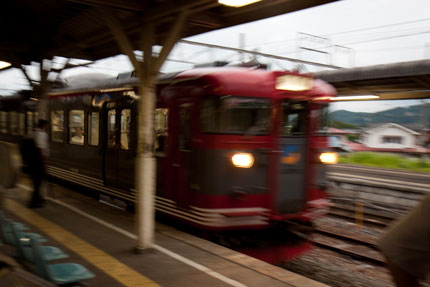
[0,178,327,287]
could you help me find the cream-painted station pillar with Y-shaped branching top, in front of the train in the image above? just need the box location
[98,6,188,251]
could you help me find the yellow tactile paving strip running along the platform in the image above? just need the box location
[5,199,159,287]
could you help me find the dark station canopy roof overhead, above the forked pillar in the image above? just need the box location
[0,0,335,67]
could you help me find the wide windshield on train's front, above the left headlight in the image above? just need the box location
[200,95,270,135]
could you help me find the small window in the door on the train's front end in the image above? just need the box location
[281,102,308,136]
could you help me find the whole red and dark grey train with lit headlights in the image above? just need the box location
[0,67,336,262]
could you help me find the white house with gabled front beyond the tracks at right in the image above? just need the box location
[361,123,420,151]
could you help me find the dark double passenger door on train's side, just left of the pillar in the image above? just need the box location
[103,102,135,189]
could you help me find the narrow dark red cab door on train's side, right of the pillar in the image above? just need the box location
[171,99,192,208]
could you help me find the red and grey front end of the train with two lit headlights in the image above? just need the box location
[170,69,336,263]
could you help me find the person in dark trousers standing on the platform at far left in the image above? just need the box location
[29,120,49,208]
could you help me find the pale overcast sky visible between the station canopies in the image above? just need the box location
[0,0,430,112]
